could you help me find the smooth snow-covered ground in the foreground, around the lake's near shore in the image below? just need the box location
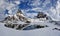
[0,22,60,36]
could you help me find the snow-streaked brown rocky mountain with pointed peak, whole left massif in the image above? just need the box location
[4,10,30,23]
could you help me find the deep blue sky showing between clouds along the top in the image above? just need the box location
[5,0,58,14]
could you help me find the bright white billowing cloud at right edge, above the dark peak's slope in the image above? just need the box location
[47,1,60,21]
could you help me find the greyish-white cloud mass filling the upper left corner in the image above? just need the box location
[0,0,20,17]
